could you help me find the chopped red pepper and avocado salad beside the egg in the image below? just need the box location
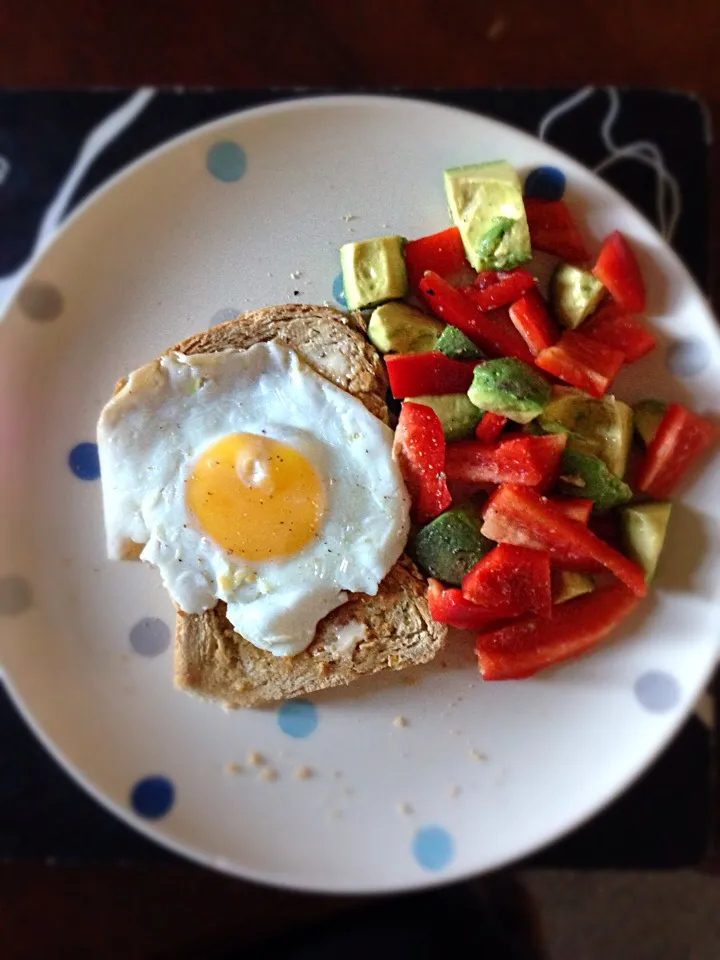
[341,161,718,680]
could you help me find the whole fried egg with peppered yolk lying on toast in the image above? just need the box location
[98,342,409,656]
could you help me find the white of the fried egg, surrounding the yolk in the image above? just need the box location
[98,342,409,656]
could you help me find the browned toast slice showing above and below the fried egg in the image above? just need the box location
[172,304,447,707]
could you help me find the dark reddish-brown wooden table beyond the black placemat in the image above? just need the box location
[0,0,720,960]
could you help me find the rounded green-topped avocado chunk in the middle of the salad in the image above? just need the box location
[468,357,550,423]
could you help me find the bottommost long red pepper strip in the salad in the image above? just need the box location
[475,583,638,680]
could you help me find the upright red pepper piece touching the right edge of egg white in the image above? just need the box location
[393,403,452,523]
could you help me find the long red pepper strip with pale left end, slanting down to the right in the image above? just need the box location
[482,484,647,597]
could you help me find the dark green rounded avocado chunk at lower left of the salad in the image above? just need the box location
[411,503,495,587]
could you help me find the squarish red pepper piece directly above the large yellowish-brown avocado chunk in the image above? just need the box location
[535,330,625,397]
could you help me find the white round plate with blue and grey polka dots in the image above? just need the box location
[0,97,720,891]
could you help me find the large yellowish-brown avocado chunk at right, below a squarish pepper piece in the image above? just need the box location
[538,387,633,477]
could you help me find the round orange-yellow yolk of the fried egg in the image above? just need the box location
[185,433,325,560]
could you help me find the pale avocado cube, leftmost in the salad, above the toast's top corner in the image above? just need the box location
[340,237,408,310]
